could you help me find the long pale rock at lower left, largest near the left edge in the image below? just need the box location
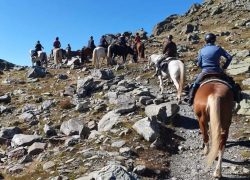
[11,134,42,146]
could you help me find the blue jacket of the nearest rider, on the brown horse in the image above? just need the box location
[197,44,232,72]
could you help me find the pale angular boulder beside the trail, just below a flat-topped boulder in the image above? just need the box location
[133,118,160,142]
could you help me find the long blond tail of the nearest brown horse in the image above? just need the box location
[207,95,221,167]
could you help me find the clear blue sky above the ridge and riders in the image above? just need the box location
[0,0,202,66]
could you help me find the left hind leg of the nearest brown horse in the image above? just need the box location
[199,114,209,155]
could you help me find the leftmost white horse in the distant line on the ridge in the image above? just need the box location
[30,50,48,67]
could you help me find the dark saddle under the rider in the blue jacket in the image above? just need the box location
[200,73,233,89]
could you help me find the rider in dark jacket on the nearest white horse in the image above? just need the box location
[156,35,177,75]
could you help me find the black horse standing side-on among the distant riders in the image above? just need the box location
[108,44,134,65]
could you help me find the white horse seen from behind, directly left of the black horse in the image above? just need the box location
[92,47,108,68]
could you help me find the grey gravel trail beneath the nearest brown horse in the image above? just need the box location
[170,105,250,180]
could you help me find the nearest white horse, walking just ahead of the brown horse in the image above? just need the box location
[148,54,185,103]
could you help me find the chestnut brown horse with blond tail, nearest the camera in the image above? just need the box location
[194,81,234,177]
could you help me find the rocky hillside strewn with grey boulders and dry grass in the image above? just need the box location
[0,0,250,180]
